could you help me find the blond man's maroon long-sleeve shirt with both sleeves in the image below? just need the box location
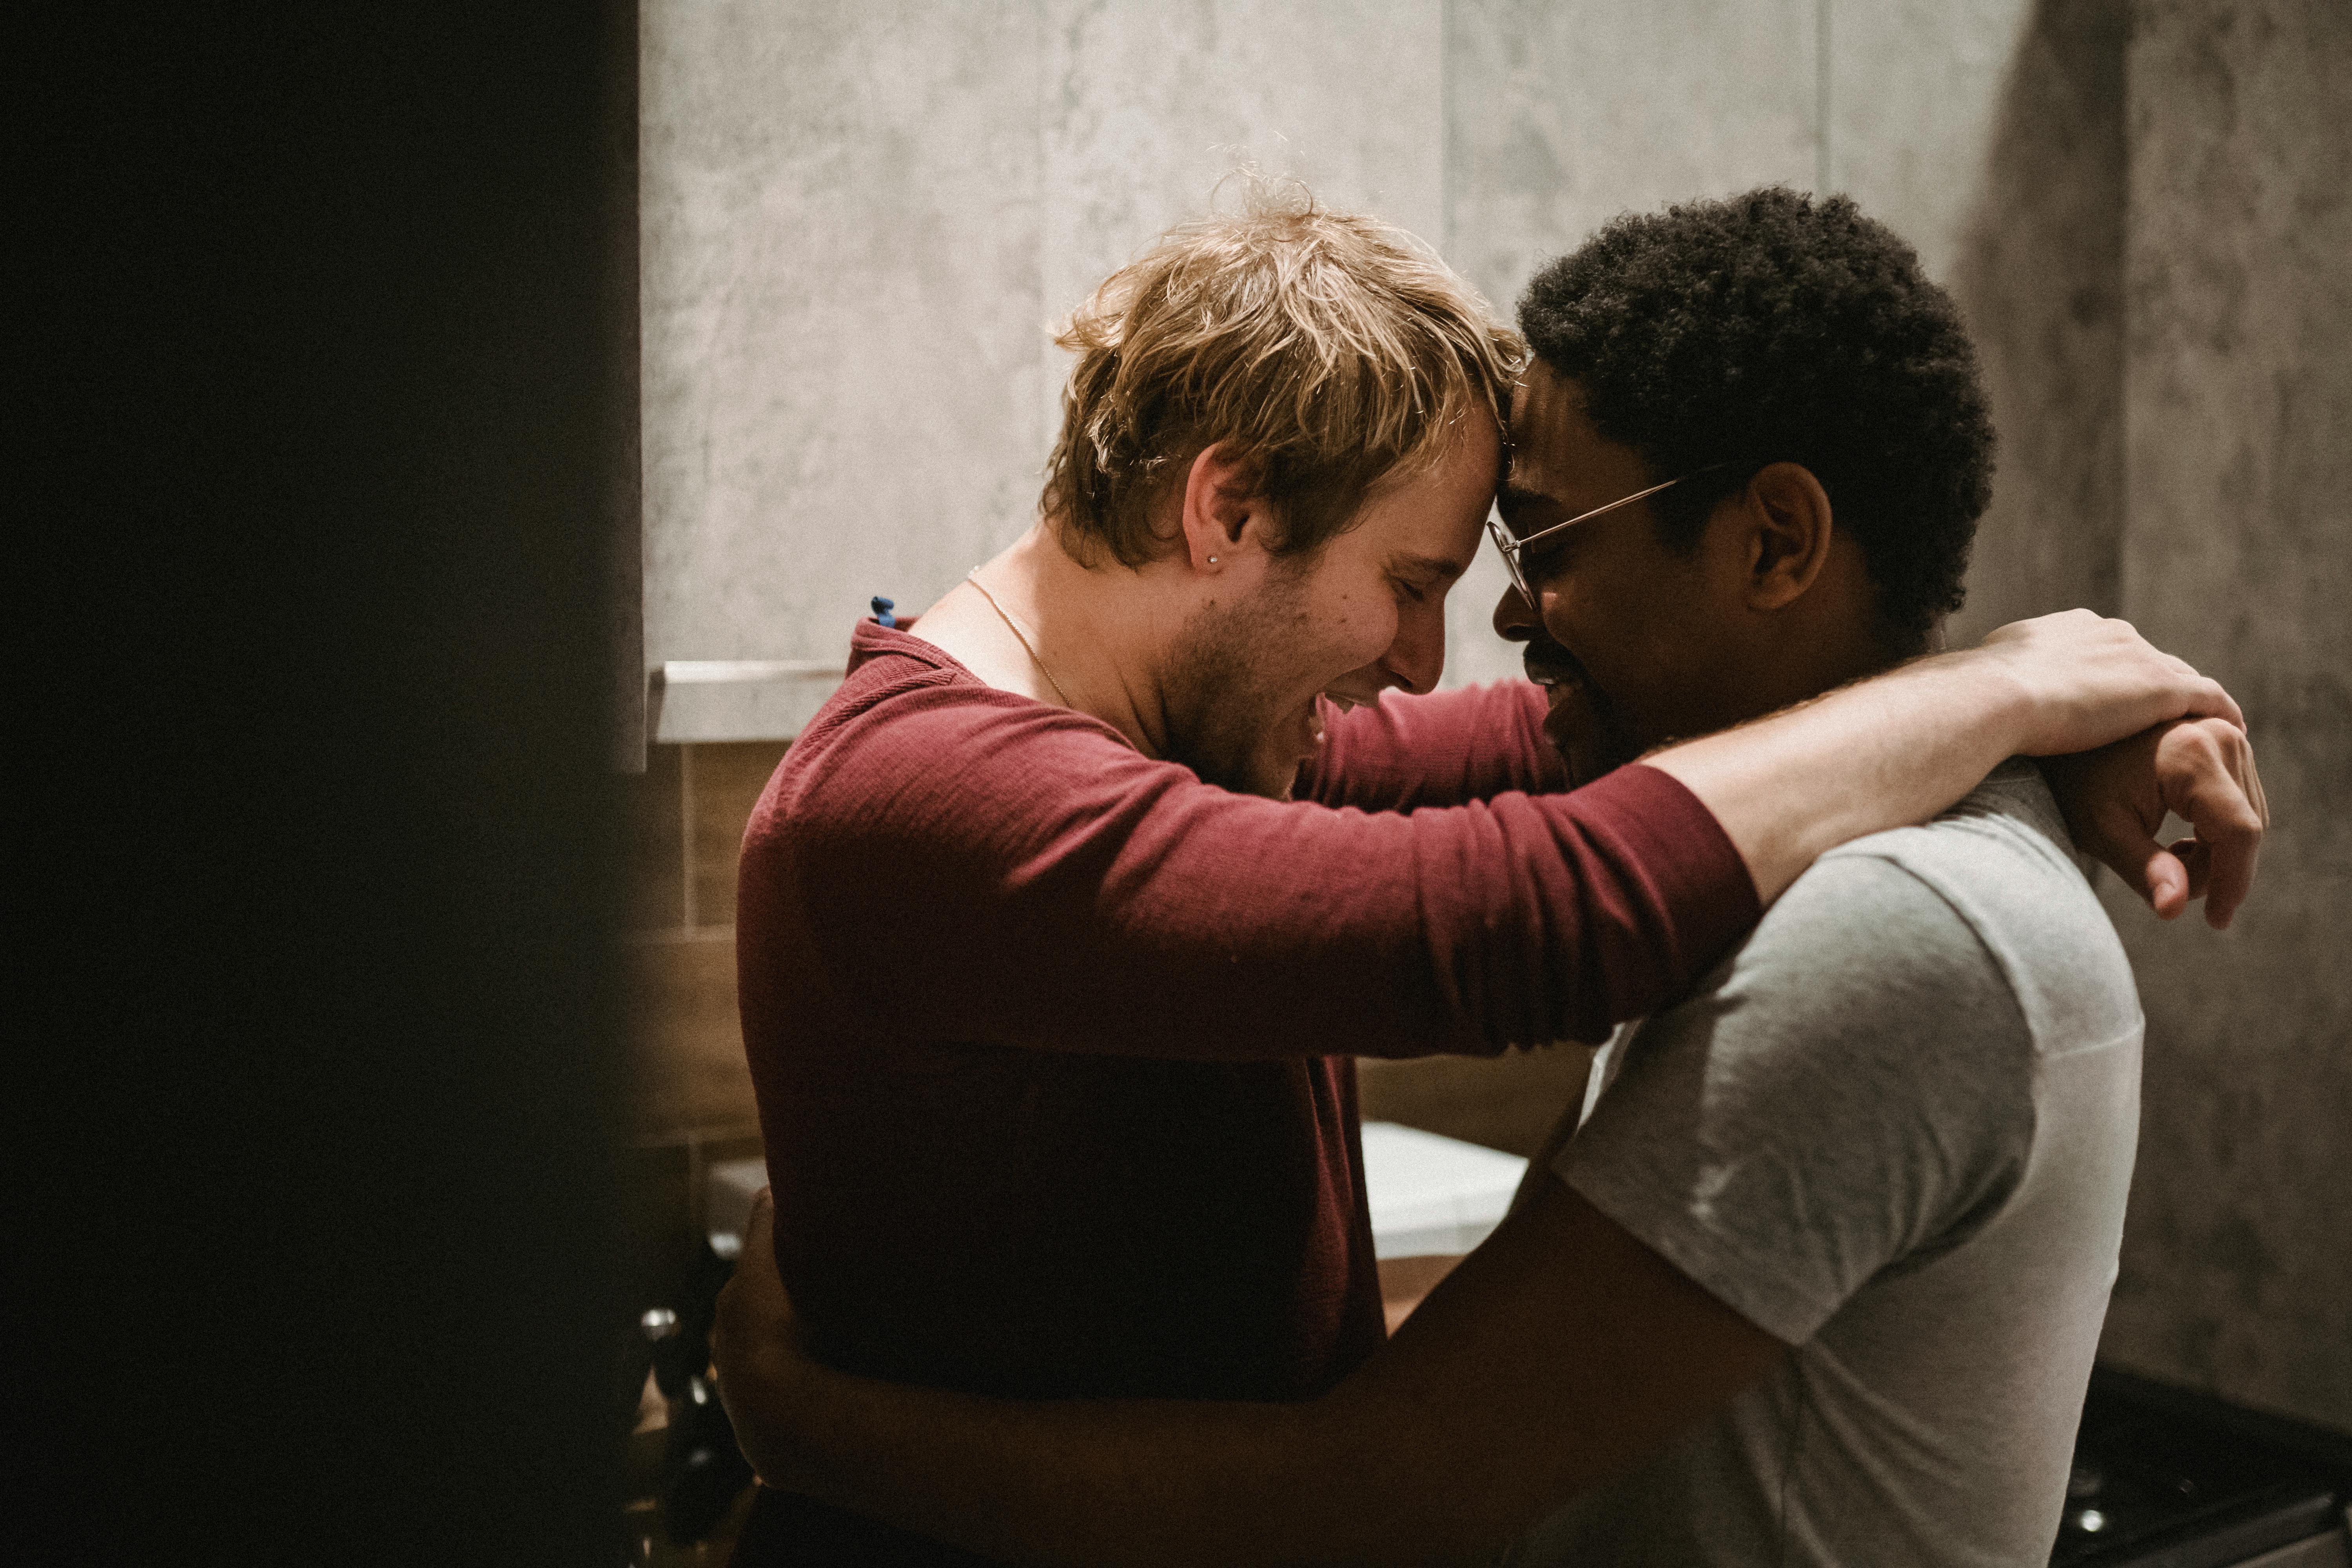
[736,621,1759,1563]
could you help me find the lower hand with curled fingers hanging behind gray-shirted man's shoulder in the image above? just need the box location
[2042,719,2270,931]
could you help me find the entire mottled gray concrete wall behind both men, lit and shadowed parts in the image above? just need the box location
[642,0,2352,1427]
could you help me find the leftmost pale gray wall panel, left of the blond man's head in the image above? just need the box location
[640,0,1047,663]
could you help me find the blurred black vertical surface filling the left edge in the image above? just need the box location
[20,2,635,1563]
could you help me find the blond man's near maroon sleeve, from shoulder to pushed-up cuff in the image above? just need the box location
[741,644,1759,1060]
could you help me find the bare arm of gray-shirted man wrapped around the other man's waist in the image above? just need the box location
[715,1182,1783,1568]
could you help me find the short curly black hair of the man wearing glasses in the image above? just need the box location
[1519,186,1992,653]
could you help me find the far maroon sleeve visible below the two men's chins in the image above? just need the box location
[1294,679,1569,811]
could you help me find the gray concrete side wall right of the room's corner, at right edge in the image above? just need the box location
[2105,0,2352,1427]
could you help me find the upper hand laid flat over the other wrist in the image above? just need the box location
[1964,609,2246,757]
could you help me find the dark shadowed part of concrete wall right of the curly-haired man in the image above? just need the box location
[1952,0,2352,1429]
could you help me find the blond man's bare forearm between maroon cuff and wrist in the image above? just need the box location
[1644,656,2025,903]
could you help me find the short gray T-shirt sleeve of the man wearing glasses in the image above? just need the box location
[1552,853,2034,1345]
